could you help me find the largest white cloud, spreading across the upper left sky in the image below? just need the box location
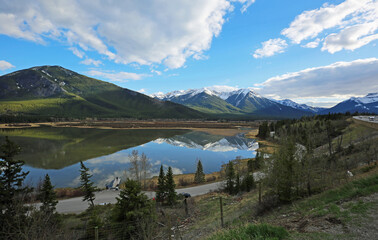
[0,0,254,68]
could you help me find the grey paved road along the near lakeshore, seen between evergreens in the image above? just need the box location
[36,182,222,213]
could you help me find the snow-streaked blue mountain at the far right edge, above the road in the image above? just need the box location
[320,93,378,114]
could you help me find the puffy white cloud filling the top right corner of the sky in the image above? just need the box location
[257,0,378,56]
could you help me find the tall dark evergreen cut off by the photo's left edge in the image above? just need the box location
[0,137,31,239]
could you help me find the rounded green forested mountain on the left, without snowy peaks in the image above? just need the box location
[0,66,204,119]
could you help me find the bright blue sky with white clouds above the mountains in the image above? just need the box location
[0,0,378,106]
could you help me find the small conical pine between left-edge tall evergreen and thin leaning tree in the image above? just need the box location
[37,174,58,214]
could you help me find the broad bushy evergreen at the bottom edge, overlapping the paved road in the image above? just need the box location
[112,179,155,239]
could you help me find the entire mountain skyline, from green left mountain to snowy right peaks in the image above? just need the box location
[0,66,378,119]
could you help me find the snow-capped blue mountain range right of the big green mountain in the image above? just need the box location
[152,87,378,118]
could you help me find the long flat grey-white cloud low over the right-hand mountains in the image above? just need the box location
[256,58,378,101]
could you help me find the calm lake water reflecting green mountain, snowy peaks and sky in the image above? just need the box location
[0,127,258,187]
